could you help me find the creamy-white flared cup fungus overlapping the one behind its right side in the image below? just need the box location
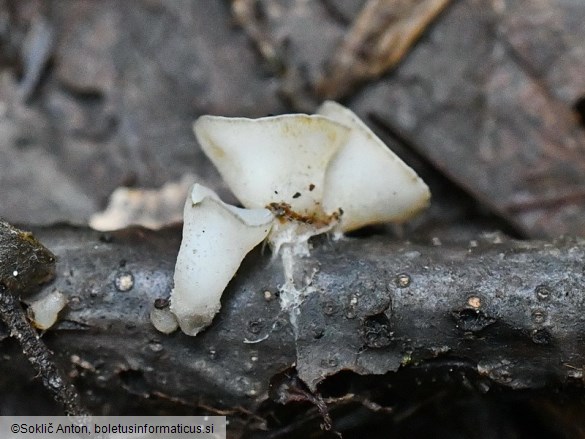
[194,114,350,217]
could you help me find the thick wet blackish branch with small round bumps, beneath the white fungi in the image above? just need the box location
[0,226,585,418]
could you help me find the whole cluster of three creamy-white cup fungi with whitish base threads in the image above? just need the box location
[171,102,430,335]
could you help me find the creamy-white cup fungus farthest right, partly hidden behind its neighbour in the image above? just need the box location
[317,101,431,232]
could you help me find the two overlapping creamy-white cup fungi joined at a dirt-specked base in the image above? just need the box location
[194,101,430,241]
